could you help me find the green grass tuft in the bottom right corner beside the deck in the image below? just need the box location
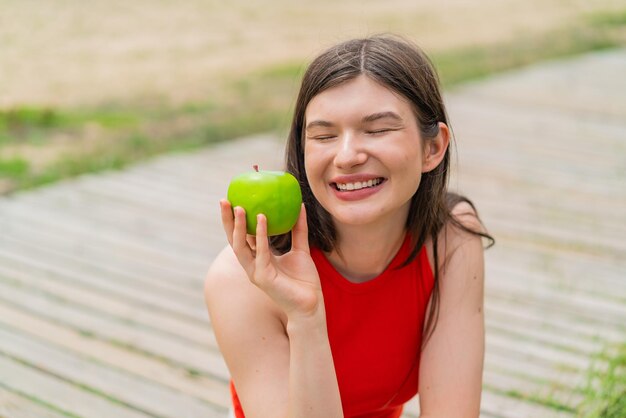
[578,343,626,418]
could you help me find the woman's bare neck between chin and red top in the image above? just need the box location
[326,217,405,283]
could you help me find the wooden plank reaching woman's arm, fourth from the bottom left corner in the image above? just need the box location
[0,304,230,409]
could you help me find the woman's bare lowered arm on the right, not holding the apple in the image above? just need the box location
[419,203,485,417]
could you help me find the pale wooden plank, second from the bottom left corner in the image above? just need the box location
[0,355,151,418]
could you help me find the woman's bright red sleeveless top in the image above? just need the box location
[231,234,434,418]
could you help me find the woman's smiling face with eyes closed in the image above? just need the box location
[304,75,423,230]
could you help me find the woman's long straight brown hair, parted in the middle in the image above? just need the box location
[271,35,494,341]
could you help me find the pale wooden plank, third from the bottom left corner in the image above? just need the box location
[0,326,227,418]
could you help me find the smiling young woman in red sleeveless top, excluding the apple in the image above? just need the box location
[205,36,491,418]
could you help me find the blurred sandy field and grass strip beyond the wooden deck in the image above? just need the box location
[0,0,626,193]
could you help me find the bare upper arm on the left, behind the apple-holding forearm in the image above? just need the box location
[204,247,289,417]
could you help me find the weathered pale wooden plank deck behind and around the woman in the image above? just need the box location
[0,50,626,418]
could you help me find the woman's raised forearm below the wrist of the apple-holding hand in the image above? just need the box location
[287,317,343,418]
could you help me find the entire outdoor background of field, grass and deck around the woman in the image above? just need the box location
[0,0,626,418]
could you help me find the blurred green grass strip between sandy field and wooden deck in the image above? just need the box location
[0,10,626,193]
